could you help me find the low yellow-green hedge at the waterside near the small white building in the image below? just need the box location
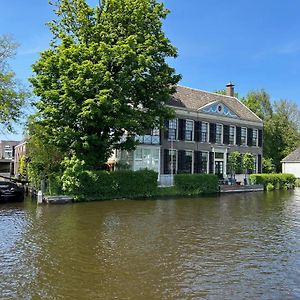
[250,173,296,190]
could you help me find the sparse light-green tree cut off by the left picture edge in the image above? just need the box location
[0,35,28,131]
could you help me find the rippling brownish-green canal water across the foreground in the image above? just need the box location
[0,189,300,300]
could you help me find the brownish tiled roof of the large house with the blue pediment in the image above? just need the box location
[168,86,262,123]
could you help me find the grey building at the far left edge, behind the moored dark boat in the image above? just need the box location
[0,140,20,180]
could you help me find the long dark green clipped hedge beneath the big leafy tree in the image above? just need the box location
[65,170,157,201]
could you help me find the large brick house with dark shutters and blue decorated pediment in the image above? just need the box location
[116,83,263,185]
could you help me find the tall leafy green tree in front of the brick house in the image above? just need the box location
[31,0,180,167]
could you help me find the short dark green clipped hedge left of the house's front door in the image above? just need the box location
[174,174,218,195]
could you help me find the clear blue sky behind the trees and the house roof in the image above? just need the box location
[0,0,300,139]
